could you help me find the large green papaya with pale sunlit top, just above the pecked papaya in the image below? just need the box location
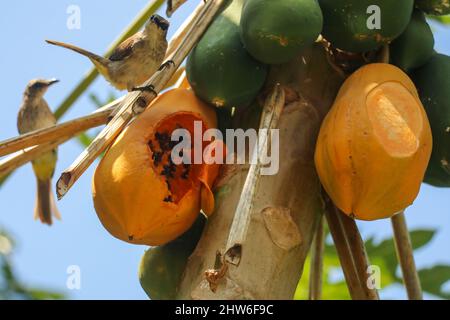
[186,0,268,108]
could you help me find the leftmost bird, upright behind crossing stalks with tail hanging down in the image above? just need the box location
[17,79,61,225]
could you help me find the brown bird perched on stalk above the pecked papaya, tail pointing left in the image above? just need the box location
[46,14,169,91]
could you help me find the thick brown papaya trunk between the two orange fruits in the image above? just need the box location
[178,44,342,299]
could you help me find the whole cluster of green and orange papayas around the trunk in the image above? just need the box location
[89,0,450,299]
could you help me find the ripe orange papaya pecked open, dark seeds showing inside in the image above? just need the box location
[92,89,220,246]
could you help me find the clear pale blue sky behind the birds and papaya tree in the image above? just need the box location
[0,0,450,299]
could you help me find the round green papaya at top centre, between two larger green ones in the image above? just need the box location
[240,0,323,64]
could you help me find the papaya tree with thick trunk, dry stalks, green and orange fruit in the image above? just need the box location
[0,0,450,300]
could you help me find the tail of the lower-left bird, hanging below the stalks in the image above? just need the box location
[34,179,61,226]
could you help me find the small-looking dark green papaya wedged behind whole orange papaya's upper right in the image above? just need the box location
[390,11,434,72]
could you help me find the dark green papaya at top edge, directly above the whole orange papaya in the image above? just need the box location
[319,0,414,52]
